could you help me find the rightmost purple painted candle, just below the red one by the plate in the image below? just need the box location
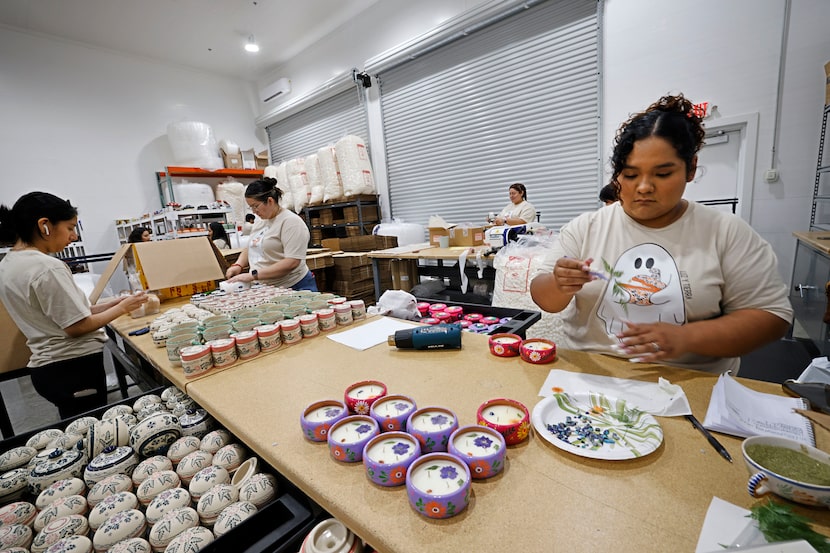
[447,425,507,480]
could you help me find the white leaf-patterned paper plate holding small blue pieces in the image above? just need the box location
[530,392,663,460]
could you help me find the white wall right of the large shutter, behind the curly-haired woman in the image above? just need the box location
[603,0,830,281]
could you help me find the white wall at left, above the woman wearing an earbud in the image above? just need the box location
[0,28,265,253]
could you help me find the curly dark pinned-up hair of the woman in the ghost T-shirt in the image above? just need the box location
[611,94,706,194]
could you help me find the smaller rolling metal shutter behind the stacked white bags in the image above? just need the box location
[266,86,369,164]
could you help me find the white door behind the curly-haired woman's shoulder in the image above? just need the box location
[684,128,742,213]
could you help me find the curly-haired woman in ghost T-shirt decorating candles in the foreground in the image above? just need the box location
[531,95,793,374]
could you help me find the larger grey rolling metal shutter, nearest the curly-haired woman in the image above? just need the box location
[378,0,601,229]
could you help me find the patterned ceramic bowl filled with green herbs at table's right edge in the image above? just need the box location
[741,436,830,507]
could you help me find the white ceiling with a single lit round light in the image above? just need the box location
[0,0,378,81]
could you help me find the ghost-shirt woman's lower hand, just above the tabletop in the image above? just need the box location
[613,322,687,363]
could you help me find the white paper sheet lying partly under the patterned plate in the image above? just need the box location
[539,369,692,417]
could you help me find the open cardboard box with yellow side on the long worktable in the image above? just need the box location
[89,236,227,303]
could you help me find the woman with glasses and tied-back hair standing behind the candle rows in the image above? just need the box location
[225,177,317,292]
